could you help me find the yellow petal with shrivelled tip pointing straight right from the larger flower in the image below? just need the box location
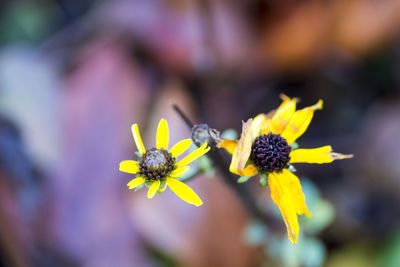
[290,146,353,164]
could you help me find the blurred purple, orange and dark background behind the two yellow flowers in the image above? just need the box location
[0,0,400,267]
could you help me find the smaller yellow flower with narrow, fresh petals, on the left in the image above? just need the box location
[119,119,210,207]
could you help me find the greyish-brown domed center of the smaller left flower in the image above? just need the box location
[139,148,175,181]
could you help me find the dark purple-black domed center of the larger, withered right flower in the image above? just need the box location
[250,133,290,173]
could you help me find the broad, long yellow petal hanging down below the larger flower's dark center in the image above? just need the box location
[268,169,311,243]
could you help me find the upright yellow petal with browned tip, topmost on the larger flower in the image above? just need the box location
[270,95,297,134]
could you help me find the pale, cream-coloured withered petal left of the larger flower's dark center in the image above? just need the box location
[229,119,256,175]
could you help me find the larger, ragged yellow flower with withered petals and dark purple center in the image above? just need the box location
[218,95,352,243]
